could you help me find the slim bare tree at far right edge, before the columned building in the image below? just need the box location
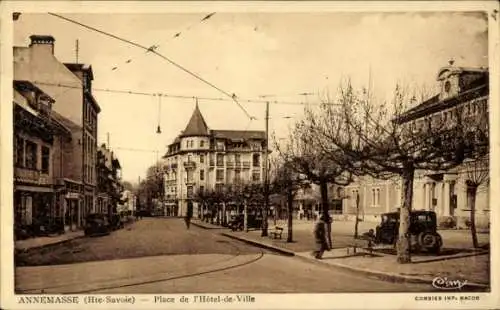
[463,155,490,248]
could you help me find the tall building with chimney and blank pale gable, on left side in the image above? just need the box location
[14,35,100,226]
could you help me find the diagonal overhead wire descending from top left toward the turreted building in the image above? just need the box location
[48,12,254,119]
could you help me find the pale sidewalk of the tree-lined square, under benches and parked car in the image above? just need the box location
[195,221,490,290]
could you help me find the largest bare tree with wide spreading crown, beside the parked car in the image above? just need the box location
[308,82,484,263]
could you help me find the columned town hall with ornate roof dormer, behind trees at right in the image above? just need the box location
[344,63,489,226]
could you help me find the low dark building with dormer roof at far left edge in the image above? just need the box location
[13,81,71,238]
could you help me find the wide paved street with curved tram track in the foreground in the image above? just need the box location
[16,218,433,293]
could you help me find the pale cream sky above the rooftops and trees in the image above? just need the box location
[14,11,488,182]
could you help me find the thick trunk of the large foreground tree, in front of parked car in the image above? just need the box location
[397,167,415,264]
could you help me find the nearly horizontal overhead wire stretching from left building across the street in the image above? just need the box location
[32,81,335,106]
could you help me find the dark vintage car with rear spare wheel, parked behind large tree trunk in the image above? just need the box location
[368,210,443,253]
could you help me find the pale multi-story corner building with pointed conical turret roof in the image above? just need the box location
[163,104,267,216]
